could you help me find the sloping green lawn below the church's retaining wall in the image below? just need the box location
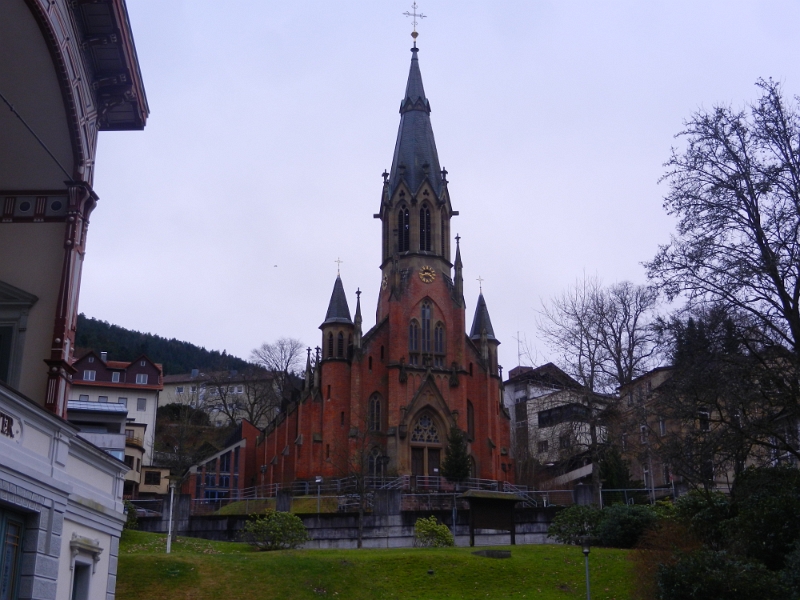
[117,531,632,600]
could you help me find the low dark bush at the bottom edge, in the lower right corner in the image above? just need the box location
[656,550,789,600]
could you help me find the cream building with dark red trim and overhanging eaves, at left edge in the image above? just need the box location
[0,0,148,600]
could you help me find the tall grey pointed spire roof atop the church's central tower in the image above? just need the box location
[389,42,443,195]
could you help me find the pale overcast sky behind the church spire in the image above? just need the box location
[80,0,800,369]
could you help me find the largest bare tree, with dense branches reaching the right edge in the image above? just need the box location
[646,80,800,455]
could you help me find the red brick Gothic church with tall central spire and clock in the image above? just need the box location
[256,39,514,485]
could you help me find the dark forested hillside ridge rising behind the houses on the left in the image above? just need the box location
[75,313,248,375]
